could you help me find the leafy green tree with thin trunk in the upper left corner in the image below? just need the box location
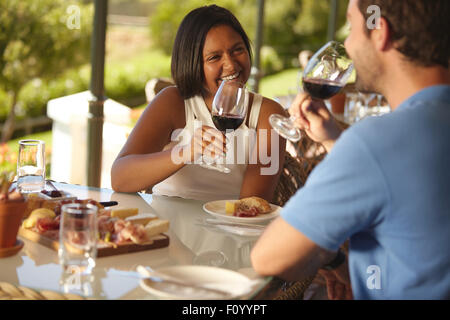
[0,0,93,142]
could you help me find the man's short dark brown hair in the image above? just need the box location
[358,0,450,68]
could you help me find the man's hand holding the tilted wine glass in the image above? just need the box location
[289,93,342,152]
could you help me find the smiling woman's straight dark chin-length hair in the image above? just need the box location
[171,5,252,99]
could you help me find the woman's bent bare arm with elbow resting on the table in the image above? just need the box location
[111,87,186,192]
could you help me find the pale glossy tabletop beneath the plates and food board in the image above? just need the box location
[0,183,272,299]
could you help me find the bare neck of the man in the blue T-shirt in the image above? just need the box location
[382,61,450,110]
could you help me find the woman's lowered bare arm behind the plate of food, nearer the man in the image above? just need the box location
[240,98,286,202]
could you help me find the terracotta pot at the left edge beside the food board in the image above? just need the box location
[0,199,27,248]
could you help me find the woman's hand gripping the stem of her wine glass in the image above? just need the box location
[183,126,227,163]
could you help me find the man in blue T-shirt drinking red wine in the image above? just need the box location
[251,0,450,299]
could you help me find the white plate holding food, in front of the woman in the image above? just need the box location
[203,200,281,223]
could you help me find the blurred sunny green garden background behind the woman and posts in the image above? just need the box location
[0,0,348,184]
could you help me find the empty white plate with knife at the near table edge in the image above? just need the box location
[140,265,260,300]
